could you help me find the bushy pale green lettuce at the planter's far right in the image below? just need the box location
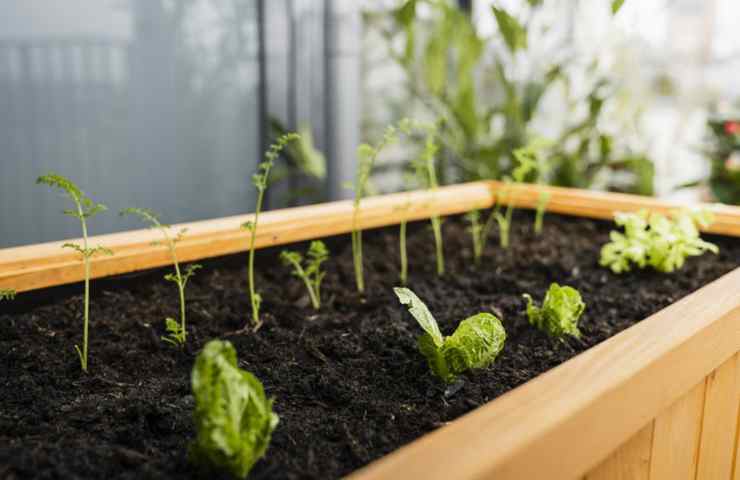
[599,210,719,273]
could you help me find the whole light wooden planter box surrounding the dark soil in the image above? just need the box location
[0,182,740,480]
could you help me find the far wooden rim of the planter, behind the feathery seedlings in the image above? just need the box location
[0,181,740,292]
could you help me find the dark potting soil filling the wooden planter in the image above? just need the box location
[0,213,740,479]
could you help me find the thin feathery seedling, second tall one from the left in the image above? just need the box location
[121,208,201,346]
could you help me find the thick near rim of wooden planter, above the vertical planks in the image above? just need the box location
[350,269,740,480]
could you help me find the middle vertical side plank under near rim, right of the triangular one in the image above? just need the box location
[650,380,706,480]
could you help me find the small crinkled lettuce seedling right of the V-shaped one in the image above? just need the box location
[524,283,586,338]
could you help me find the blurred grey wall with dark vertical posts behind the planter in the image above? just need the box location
[0,0,360,248]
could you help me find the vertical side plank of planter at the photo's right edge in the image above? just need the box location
[696,355,739,480]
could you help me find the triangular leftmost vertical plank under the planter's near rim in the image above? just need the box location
[585,422,654,480]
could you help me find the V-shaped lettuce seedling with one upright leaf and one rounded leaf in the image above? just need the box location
[393,287,506,383]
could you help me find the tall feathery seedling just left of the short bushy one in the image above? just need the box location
[242,133,300,331]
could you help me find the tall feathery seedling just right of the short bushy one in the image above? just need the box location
[348,125,398,292]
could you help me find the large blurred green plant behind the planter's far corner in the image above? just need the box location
[382,0,654,194]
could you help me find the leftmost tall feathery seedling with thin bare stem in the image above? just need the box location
[36,173,113,373]
